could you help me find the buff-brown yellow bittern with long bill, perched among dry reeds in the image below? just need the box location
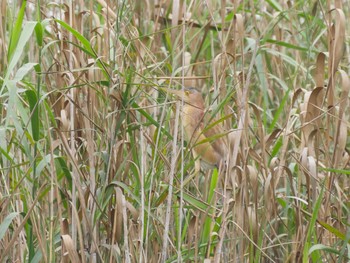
[166,87,228,171]
